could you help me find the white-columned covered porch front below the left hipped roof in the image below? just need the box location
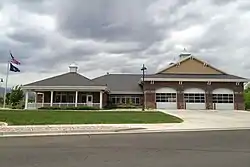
[22,86,107,110]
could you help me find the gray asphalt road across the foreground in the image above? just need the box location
[0,130,250,167]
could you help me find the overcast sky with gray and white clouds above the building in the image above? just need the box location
[0,0,250,86]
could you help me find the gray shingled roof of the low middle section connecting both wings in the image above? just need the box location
[93,74,142,93]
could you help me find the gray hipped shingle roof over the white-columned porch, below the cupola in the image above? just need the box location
[24,72,105,86]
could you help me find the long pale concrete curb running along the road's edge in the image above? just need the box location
[0,127,250,138]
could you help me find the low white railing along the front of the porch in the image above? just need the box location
[27,103,100,109]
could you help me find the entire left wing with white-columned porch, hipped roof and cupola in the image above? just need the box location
[22,64,107,109]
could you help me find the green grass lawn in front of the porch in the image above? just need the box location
[0,110,182,125]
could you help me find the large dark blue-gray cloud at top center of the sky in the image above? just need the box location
[54,0,161,43]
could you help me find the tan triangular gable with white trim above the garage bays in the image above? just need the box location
[157,56,226,74]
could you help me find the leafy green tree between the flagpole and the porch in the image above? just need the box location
[6,85,24,106]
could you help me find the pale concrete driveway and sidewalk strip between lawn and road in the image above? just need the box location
[0,110,250,137]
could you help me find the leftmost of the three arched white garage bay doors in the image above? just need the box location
[155,87,177,109]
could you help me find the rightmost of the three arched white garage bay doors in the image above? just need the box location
[213,88,234,110]
